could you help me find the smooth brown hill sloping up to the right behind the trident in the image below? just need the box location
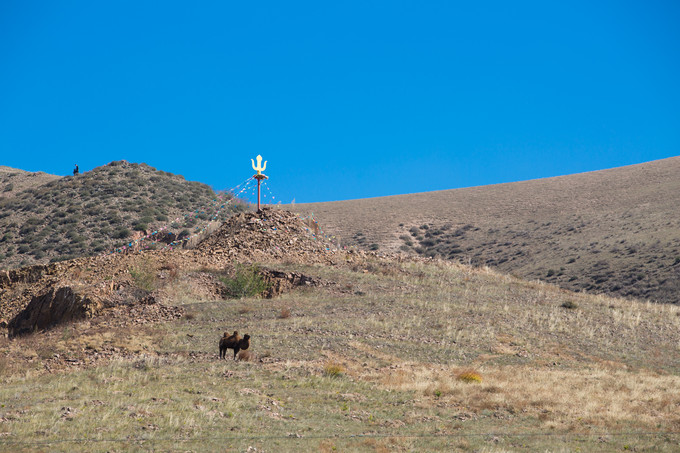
[294,157,680,303]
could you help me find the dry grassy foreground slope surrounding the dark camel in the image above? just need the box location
[0,258,680,452]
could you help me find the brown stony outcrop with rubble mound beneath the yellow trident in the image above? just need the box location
[0,208,378,336]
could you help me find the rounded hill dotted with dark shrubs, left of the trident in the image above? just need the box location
[0,161,248,269]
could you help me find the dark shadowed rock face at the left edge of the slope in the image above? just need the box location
[8,286,103,336]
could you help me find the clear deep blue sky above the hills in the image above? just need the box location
[0,0,680,203]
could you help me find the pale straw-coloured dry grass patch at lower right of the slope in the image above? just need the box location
[379,364,680,430]
